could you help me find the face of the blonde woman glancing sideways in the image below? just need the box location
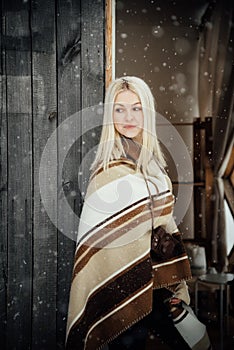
[113,90,144,143]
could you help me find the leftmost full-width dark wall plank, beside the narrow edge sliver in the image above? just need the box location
[5,1,32,350]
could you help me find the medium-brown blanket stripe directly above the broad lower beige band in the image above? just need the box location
[72,207,171,280]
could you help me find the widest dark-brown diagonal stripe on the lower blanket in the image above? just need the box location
[66,256,152,350]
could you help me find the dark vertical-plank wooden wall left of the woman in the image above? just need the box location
[0,0,105,350]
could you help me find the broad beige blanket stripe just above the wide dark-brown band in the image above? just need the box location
[68,236,149,330]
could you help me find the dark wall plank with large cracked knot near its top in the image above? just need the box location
[57,0,81,349]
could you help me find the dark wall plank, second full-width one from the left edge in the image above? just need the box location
[31,0,57,350]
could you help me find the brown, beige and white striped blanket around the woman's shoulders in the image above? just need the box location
[66,159,191,350]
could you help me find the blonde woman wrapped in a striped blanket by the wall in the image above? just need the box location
[66,77,191,350]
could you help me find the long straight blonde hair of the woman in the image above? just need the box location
[91,76,166,172]
